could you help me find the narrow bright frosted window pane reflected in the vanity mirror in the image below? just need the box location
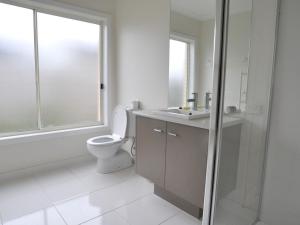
[169,40,188,107]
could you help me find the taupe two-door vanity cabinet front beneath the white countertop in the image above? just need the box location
[136,116,208,216]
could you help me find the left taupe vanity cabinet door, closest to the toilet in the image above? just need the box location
[136,116,167,187]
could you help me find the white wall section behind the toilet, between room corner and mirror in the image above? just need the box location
[116,0,170,109]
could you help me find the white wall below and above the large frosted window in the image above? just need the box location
[0,0,115,173]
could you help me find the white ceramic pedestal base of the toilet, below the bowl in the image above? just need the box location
[97,149,133,173]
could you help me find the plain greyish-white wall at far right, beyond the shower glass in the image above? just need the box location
[261,0,300,225]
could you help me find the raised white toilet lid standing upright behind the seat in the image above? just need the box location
[112,106,127,138]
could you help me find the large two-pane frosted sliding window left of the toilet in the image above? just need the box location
[0,3,104,136]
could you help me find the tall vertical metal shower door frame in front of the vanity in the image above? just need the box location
[202,0,229,225]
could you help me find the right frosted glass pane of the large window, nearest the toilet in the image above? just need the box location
[37,13,100,127]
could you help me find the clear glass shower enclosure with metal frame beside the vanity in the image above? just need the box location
[202,0,278,225]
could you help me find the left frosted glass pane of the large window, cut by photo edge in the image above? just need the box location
[0,3,37,135]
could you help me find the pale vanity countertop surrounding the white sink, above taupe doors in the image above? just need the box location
[133,110,243,130]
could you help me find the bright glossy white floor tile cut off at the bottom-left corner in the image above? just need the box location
[3,208,66,225]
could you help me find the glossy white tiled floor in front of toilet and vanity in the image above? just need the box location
[0,157,201,225]
